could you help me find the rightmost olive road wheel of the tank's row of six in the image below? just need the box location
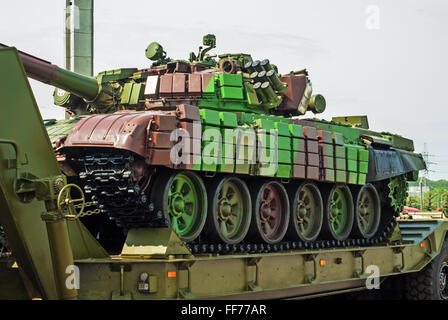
[353,183,381,239]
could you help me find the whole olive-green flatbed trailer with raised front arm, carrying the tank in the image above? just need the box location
[0,48,448,299]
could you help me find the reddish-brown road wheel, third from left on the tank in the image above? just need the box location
[250,181,289,244]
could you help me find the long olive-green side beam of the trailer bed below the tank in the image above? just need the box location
[75,219,448,299]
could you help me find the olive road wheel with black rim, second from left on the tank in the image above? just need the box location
[205,177,252,244]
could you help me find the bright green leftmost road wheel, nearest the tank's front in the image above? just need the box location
[151,171,207,242]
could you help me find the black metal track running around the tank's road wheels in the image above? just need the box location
[76,151,397,254]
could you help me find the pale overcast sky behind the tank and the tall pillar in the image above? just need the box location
[0,0,448,179]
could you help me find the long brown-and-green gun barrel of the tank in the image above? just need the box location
[0,43,100,101]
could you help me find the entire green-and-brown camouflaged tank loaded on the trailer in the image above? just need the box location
[0,35,425,252]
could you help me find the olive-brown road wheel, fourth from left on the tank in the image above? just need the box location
[287,182,324,241]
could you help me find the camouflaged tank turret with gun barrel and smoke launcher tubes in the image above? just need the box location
[0,34,325,116]
